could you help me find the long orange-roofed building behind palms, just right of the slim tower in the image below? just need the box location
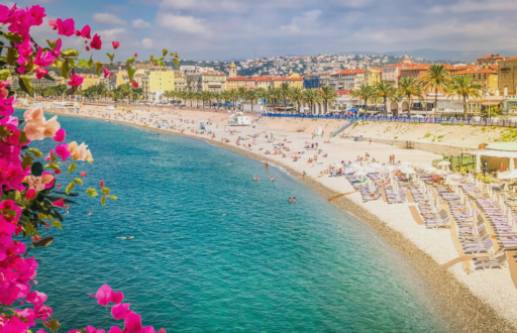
[226,74,303,90]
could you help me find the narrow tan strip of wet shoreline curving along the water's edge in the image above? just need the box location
[47,105,516,332]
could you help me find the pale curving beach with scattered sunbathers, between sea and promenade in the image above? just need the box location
[38,105,517,332]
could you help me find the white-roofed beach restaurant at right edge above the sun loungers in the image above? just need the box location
[474,142,517,179]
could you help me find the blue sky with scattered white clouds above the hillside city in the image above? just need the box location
[8,0,517,59]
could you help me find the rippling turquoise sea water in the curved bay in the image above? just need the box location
[33,117,446,332]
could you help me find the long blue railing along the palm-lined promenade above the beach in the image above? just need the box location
[262,112,517,128]
